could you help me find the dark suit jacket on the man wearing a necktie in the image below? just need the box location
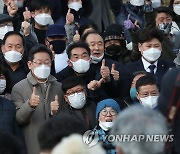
[120,59,175,97]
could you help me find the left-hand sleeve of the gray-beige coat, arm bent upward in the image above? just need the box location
[11,85,35,125]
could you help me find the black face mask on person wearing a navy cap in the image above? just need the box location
[50,40,66,54]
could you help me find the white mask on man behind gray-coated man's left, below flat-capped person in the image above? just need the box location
[4,50,22,63]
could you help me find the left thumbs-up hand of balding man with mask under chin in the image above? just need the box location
[100,59,110,81]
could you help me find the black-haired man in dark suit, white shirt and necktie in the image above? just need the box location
[120,29,174,97]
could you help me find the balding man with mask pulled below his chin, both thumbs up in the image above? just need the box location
[81,32,120,98]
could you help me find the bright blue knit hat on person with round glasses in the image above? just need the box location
[96,99,120,119]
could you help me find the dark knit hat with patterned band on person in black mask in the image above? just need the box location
[103,24,124,41]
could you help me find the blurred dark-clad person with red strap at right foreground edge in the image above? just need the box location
[158,68,180,154]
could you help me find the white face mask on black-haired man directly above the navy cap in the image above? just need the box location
[34,13,54,26]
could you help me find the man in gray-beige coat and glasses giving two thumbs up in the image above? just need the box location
[12,44,63,154]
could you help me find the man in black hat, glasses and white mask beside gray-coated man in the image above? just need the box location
[62,76,96,129]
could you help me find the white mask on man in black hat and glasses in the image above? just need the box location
[68,92,86,109]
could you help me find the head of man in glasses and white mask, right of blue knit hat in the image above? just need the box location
[136,75,159,109]
